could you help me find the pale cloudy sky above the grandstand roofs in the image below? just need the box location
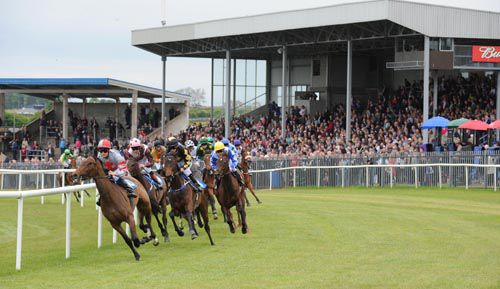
[0,0,500,103]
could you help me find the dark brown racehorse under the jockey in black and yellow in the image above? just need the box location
[163,154,214,245]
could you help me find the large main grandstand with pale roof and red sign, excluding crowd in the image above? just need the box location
[132,0,500,143]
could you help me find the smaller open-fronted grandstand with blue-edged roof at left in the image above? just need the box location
[0,78,190,156]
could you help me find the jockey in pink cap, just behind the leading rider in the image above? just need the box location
[125,138,163,188]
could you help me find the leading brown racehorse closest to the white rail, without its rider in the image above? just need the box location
[74,156,156,261]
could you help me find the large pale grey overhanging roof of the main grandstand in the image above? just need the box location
[132,0,500,59]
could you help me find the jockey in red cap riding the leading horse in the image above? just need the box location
[97,139,137,207]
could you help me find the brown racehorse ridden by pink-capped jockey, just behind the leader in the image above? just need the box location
[127,158,170,242]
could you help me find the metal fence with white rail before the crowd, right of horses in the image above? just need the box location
[252,151,500,189]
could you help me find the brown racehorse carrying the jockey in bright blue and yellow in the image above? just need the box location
[216,153,248,234]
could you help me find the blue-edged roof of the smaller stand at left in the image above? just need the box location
[0,78,190,101]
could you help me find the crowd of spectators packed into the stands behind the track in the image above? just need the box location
[1,74,496,164]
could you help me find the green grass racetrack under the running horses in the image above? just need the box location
[0,188,500,288]
